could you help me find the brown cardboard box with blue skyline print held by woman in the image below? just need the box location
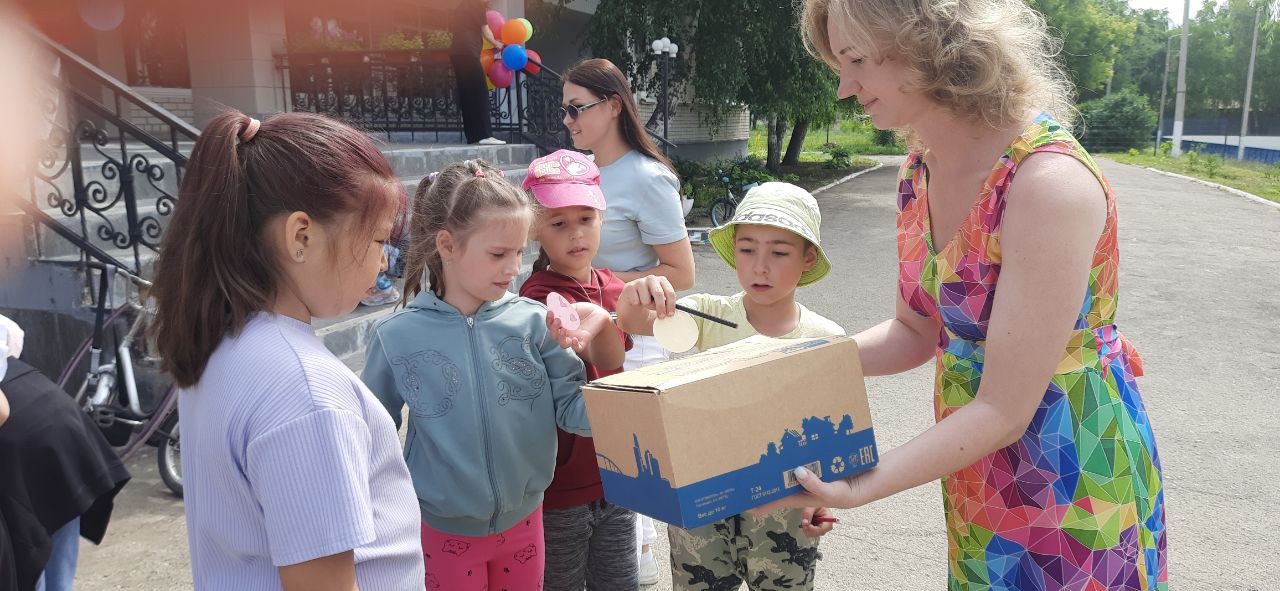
[582,336,879,527]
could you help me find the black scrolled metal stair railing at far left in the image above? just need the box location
[24,32,200,275]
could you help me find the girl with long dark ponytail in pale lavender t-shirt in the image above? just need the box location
[154,113,425,591]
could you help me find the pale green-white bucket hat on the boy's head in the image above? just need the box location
[709,183,831,287]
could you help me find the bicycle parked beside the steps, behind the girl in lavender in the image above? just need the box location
[58,261,183,496]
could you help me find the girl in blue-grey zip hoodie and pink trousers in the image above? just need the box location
[364,160,622,591]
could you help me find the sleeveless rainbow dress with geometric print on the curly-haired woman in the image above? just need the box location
[897,114,1167,591]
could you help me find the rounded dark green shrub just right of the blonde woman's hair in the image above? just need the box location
[1078,88,1156,152]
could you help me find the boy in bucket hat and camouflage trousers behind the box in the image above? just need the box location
[617,183,845,591]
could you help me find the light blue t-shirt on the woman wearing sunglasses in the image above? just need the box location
[593,150,689,272]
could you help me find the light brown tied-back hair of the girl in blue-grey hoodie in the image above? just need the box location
[403,160,532,301]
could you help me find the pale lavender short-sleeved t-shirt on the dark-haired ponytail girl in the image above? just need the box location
[179,312,425,590]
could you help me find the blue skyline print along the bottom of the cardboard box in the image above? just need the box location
[596,414,879,528]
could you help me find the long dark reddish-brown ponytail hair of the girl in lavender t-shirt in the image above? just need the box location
[152,111,403,386]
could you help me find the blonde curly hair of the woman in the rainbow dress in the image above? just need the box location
[800,0,1075,132]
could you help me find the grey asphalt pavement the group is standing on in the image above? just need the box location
[77,162,1280,591]
